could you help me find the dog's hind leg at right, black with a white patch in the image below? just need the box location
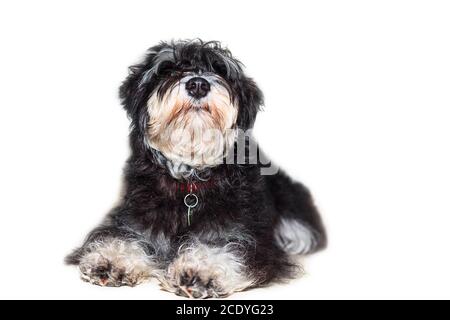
[266,172,327,255]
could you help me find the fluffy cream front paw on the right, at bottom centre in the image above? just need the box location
[161,243,254,298]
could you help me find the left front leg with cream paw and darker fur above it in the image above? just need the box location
[66,228,160,287]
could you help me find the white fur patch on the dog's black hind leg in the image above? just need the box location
[275,218,316,255]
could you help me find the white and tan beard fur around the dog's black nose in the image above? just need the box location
[146,76,238,171]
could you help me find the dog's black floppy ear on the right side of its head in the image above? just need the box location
[237,76,264,130]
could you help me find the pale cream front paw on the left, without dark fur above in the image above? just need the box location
[79,239,153,287]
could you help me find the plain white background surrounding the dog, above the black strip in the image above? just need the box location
[0,0,450,299]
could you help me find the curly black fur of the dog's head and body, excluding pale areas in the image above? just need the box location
[66,40,326,296]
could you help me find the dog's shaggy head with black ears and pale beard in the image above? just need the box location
[120,40,263,168]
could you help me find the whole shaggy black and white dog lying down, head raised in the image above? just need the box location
[66,40,326,298]
